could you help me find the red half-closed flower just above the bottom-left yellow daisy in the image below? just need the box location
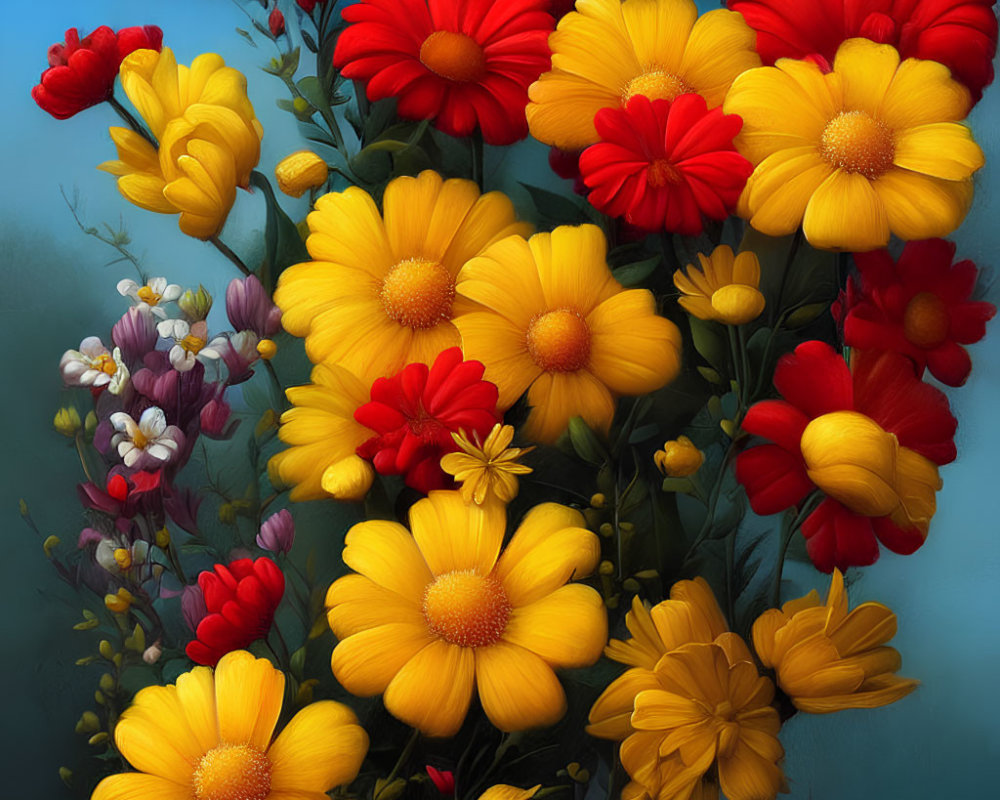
[186,557,285,667]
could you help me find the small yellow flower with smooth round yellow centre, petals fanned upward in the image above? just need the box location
[674,245,764,325]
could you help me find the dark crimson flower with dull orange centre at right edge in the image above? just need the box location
[844,239,997,386]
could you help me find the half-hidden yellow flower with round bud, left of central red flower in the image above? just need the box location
[268,364,375,502]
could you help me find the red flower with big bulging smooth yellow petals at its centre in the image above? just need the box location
[736,341,956,572]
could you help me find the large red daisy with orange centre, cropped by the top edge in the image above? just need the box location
[333,0,555,145]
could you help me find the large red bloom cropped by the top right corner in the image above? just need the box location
[729,0,997,101]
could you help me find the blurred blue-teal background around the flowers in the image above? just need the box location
[0,0,1000,800]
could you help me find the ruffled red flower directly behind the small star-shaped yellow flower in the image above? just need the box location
[354,347,501,494]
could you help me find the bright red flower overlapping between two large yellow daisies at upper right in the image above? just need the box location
[580,94,753,236]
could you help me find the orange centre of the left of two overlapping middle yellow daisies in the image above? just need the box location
[379,258,455,328]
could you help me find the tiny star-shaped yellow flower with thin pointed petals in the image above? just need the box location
[441,422,535,505]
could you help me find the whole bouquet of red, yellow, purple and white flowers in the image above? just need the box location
[21,0,997,800]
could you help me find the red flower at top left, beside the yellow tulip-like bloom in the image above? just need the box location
[31,25,163,119]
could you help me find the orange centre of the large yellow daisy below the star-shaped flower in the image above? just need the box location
[424,570,510,647]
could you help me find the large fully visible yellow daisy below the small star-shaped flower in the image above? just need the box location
[326,492,607,736]
